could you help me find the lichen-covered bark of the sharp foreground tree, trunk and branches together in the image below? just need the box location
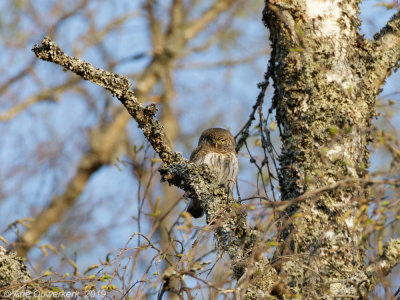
[27,1,400,299]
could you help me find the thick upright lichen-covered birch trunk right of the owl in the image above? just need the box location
[263,1,394,299]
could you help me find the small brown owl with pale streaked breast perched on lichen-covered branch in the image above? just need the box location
[187,128,239,218]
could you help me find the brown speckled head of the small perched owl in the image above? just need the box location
[199,128,235,151]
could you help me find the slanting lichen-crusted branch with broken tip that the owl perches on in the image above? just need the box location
[32,37,279,297]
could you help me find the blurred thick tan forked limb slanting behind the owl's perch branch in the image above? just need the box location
[14,0,236,256]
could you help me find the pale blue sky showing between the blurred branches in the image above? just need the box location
[0,0,400,296]
